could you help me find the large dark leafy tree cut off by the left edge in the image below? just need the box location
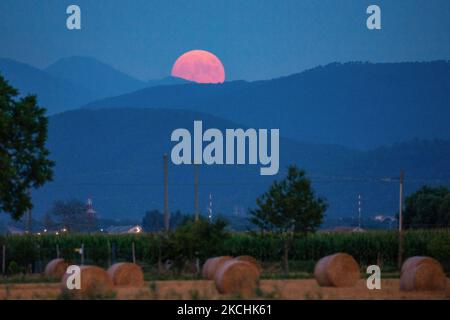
[0,75,53,220]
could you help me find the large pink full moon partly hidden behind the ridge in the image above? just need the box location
[171,50,225,83]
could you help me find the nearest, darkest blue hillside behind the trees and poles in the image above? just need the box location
[29,108,450,222]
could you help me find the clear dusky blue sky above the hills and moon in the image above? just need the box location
[0,0,450,80]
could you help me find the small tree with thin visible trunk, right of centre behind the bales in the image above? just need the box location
[250,166,327,273]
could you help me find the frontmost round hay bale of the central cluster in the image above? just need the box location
[214,260,260,297]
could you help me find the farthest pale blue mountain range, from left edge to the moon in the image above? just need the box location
[0,57,189,115]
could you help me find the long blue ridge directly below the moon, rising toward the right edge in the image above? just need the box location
[86,61,450,149]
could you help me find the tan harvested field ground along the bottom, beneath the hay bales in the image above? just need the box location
[0,278,450,299]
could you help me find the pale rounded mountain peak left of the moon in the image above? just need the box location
[45,56,146,99]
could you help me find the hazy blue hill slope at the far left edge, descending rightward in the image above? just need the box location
[0,58,98,114]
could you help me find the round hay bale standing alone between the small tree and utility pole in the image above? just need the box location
[314,253,360,287]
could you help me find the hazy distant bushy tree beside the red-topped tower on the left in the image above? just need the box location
[49,199,96,232]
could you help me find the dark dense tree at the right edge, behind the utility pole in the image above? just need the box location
[403,186,450,229]
